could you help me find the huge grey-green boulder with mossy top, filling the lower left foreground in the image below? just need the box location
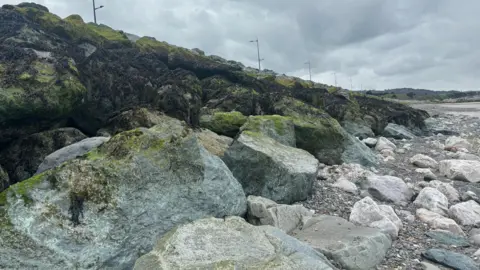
[0,114,246,269]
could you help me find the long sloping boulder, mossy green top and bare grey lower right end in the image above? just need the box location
[274,97,377,166]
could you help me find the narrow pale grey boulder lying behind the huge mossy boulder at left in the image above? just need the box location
[35,137,110,174]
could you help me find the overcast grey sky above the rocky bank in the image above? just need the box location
[0,0,480,90]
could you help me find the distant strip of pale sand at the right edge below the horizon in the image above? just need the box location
[410,102,480,118]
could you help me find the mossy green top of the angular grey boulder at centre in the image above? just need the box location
[240,115,296,147]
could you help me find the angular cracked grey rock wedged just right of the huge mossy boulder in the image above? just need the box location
[247,195,313,233]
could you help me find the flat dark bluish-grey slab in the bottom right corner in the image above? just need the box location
[422,248,480,270]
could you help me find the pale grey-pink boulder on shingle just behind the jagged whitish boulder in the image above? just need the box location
[359,175,414,205]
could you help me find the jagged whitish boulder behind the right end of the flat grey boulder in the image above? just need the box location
[349,197,403,239]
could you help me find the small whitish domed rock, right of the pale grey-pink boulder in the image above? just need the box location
[413,187,448,216]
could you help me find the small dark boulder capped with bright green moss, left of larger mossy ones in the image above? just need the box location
[200,111,247,137]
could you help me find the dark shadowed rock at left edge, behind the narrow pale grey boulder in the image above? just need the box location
[0,128,87,188]
